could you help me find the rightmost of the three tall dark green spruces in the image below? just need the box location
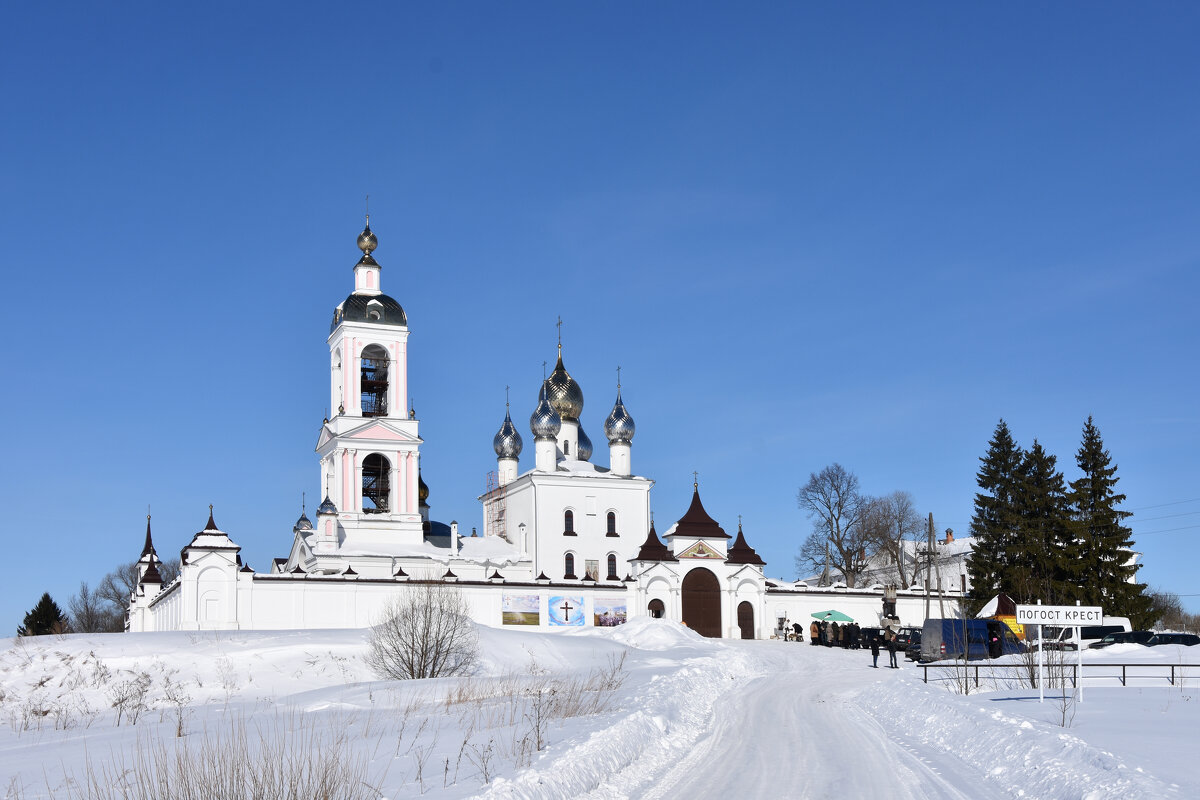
[1068,416,1152,618]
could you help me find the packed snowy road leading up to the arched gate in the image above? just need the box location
[643,648,1008,800]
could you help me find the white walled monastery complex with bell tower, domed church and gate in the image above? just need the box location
[127,219,960,638]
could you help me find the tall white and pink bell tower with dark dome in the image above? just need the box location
[317,216,422,552]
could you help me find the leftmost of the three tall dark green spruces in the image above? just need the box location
[967,420,1022,607]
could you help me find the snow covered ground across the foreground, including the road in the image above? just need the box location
[0,619,1200,800]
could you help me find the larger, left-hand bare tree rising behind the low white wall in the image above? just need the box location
[796,464,871,587]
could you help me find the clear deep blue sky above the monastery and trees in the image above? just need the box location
[0,2,1200,628]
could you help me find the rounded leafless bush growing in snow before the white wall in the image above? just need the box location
[366,581,479,680]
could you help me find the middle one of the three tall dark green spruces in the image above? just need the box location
[1009,439,1076,603]
